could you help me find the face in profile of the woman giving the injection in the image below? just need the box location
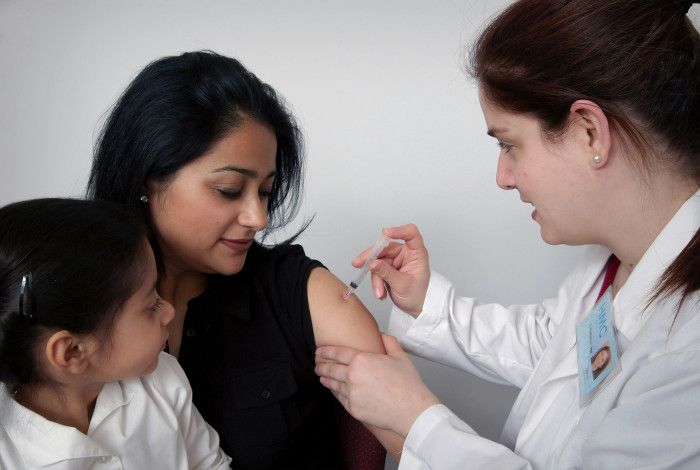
[479,87,596,245]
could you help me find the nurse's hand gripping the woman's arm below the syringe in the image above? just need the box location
[316,335,440,438]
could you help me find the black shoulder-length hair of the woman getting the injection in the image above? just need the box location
[87,51,303,273]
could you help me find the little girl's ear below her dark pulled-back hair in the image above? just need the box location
[45,330,97,375]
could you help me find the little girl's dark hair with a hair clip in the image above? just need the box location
[0,199,148,387]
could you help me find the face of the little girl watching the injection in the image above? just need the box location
[96,240,175,382]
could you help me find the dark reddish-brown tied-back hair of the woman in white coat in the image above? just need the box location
[468,0,700,302]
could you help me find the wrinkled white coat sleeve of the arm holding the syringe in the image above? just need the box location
[388,271,571,387]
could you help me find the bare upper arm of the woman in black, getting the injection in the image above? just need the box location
[308,268,385,353]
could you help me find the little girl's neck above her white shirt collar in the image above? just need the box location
[14,383,104,434]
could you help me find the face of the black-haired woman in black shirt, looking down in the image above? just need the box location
[148,119,277,275]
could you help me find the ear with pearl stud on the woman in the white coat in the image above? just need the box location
[569,100,611,169]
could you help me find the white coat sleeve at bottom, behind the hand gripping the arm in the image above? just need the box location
[399,405,532,470]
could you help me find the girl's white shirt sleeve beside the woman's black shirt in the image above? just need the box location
[153,353,231,470]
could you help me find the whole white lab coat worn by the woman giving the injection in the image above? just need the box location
[389,191,700,470]
